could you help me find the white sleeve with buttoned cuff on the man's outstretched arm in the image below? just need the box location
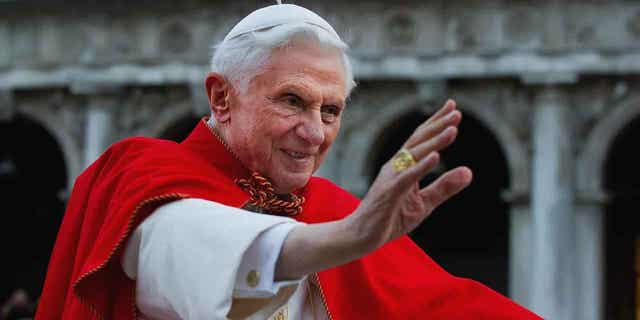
[121,199,304,319]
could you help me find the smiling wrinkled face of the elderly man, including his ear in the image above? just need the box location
[225,43,346,193]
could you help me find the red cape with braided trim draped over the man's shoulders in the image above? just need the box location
[36,121,540,320]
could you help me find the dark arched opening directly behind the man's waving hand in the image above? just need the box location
[369,95,510,293]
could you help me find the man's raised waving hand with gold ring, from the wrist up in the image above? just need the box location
[351,100,472,249]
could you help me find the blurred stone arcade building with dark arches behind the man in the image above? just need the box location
[0,0,640,320]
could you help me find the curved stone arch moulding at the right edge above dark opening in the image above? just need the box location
[576,96,640,192]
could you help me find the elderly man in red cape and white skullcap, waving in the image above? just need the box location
[37,5,537,319]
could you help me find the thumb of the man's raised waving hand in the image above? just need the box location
[420,167,473,211]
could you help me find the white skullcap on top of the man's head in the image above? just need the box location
[223,4,340,42]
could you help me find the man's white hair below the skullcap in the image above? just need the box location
[211,23,356,97]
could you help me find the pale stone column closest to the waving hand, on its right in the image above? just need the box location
[529,86,576,320]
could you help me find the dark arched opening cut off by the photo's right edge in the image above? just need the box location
[603,116,640,319]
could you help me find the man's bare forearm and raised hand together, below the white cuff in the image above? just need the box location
[275,100,472,280]
